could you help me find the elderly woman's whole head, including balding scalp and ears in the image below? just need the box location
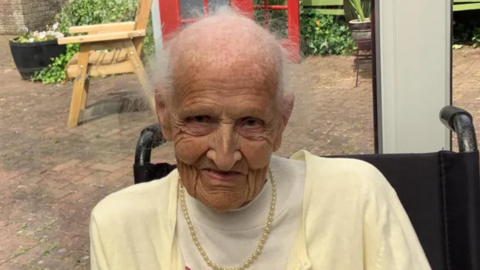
[156,15,294,211]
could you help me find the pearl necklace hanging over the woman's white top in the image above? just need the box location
[180,167,277,270]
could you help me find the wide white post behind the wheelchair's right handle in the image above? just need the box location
[376,0,452,153]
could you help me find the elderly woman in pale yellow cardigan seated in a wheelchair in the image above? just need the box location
[90,7,430,270]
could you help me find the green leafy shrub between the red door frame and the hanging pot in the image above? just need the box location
[300,8,354,55]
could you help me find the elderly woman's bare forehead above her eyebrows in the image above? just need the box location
[172,35,282,91]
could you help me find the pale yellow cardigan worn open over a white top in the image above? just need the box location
[90,151,431,270]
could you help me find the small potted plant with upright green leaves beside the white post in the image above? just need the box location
[344,0,372,40]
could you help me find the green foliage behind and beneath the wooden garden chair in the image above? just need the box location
[32,0,154,83]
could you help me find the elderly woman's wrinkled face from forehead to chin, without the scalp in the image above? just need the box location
[159,56,293,211]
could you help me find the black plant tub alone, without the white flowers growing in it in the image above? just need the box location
[10,39,67,80]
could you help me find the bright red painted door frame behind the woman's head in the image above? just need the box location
[158,0,300,61]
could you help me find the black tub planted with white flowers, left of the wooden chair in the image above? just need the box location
[9,23,66,80]
